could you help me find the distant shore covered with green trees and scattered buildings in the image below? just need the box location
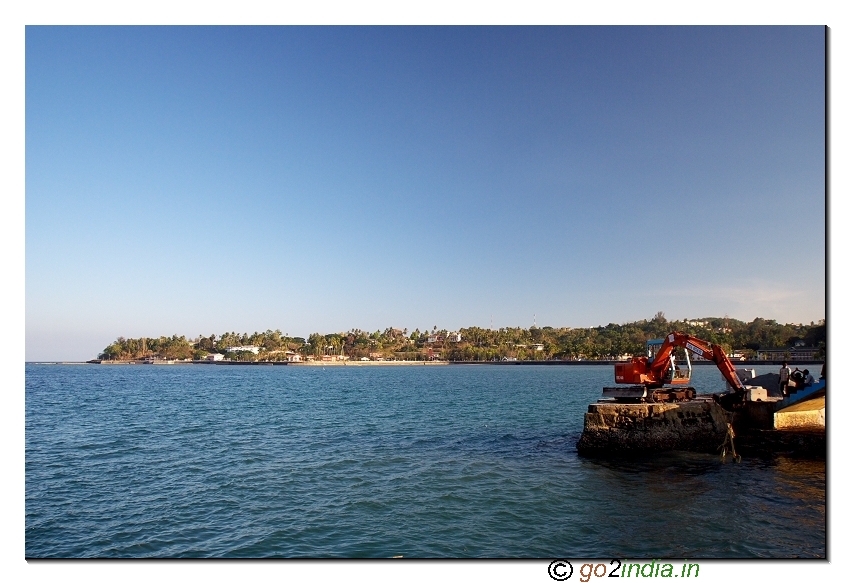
[98,312,826,362]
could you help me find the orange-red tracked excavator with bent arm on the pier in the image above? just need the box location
[603,332,747,410]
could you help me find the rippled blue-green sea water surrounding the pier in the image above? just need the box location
[25,364,826,559]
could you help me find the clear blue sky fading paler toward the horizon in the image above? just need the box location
[25,26,826,360]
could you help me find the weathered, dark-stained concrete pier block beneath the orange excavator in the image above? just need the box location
[576,397,728,455]
